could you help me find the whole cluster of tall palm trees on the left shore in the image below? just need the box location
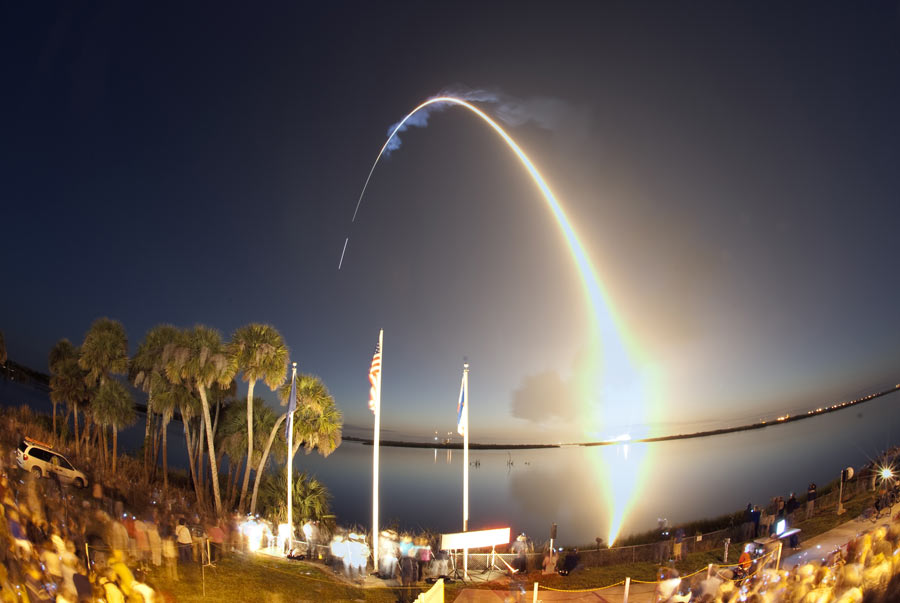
[39,318,343,516]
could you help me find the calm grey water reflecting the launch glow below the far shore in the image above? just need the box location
[0,380,900,544]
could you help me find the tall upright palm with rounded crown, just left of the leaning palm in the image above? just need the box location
[229,323,288,510]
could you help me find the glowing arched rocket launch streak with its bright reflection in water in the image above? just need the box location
[350,96,652,545]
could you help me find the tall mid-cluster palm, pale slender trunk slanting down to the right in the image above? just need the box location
[166,325,235,517]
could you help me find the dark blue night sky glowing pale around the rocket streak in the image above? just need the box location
[0,2,900,441]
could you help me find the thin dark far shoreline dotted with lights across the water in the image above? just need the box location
[343,383,900,450]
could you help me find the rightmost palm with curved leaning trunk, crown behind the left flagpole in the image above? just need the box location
[250,374,344,513]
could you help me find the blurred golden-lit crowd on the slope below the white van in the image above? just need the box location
[0,438,250,603]
